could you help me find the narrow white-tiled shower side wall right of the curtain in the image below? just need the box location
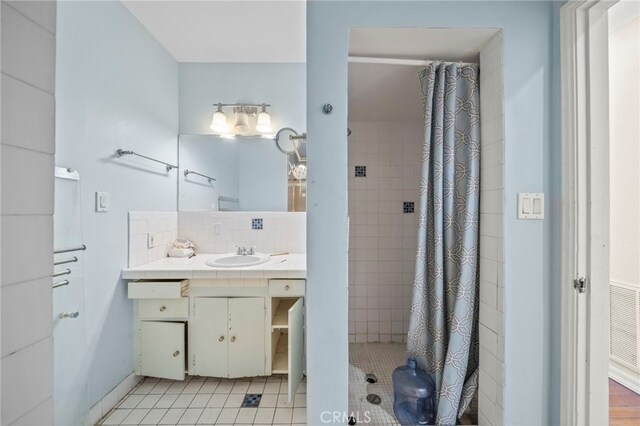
[478,34,504,424]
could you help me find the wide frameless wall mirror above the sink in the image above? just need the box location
[178,134,306,211]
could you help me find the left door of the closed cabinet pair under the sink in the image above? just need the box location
[189,297,229,377]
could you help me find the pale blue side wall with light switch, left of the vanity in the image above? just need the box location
[55,1,178,410]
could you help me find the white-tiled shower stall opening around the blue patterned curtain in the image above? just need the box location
[348,28,504,424]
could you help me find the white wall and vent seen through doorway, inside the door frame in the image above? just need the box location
[609,1,640,424]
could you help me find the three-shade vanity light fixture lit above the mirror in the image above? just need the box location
[211,103,272,138]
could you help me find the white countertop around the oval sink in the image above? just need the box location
[122,253,307,280]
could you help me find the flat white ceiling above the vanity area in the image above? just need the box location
[123,0,306,62]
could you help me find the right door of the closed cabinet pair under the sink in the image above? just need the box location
[229,297,266,377]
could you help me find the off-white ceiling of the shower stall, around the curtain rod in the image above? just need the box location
[349,28,498,121]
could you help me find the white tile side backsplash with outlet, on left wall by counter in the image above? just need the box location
[129,212,178,267]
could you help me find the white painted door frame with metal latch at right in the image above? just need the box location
[560,0,618,425]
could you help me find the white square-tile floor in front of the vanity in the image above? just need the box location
[98,375,307,425]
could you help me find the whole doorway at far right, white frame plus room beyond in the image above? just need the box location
[561,1,640,424]
